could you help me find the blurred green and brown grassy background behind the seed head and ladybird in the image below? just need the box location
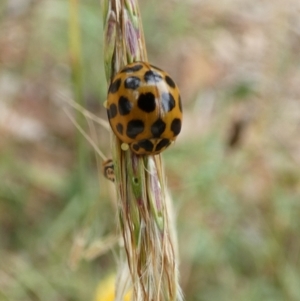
[0,0,300,301]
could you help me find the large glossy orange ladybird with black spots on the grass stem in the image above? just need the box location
[106,62,182,155]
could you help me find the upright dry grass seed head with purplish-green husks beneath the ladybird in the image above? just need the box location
[103,0,182,301]
